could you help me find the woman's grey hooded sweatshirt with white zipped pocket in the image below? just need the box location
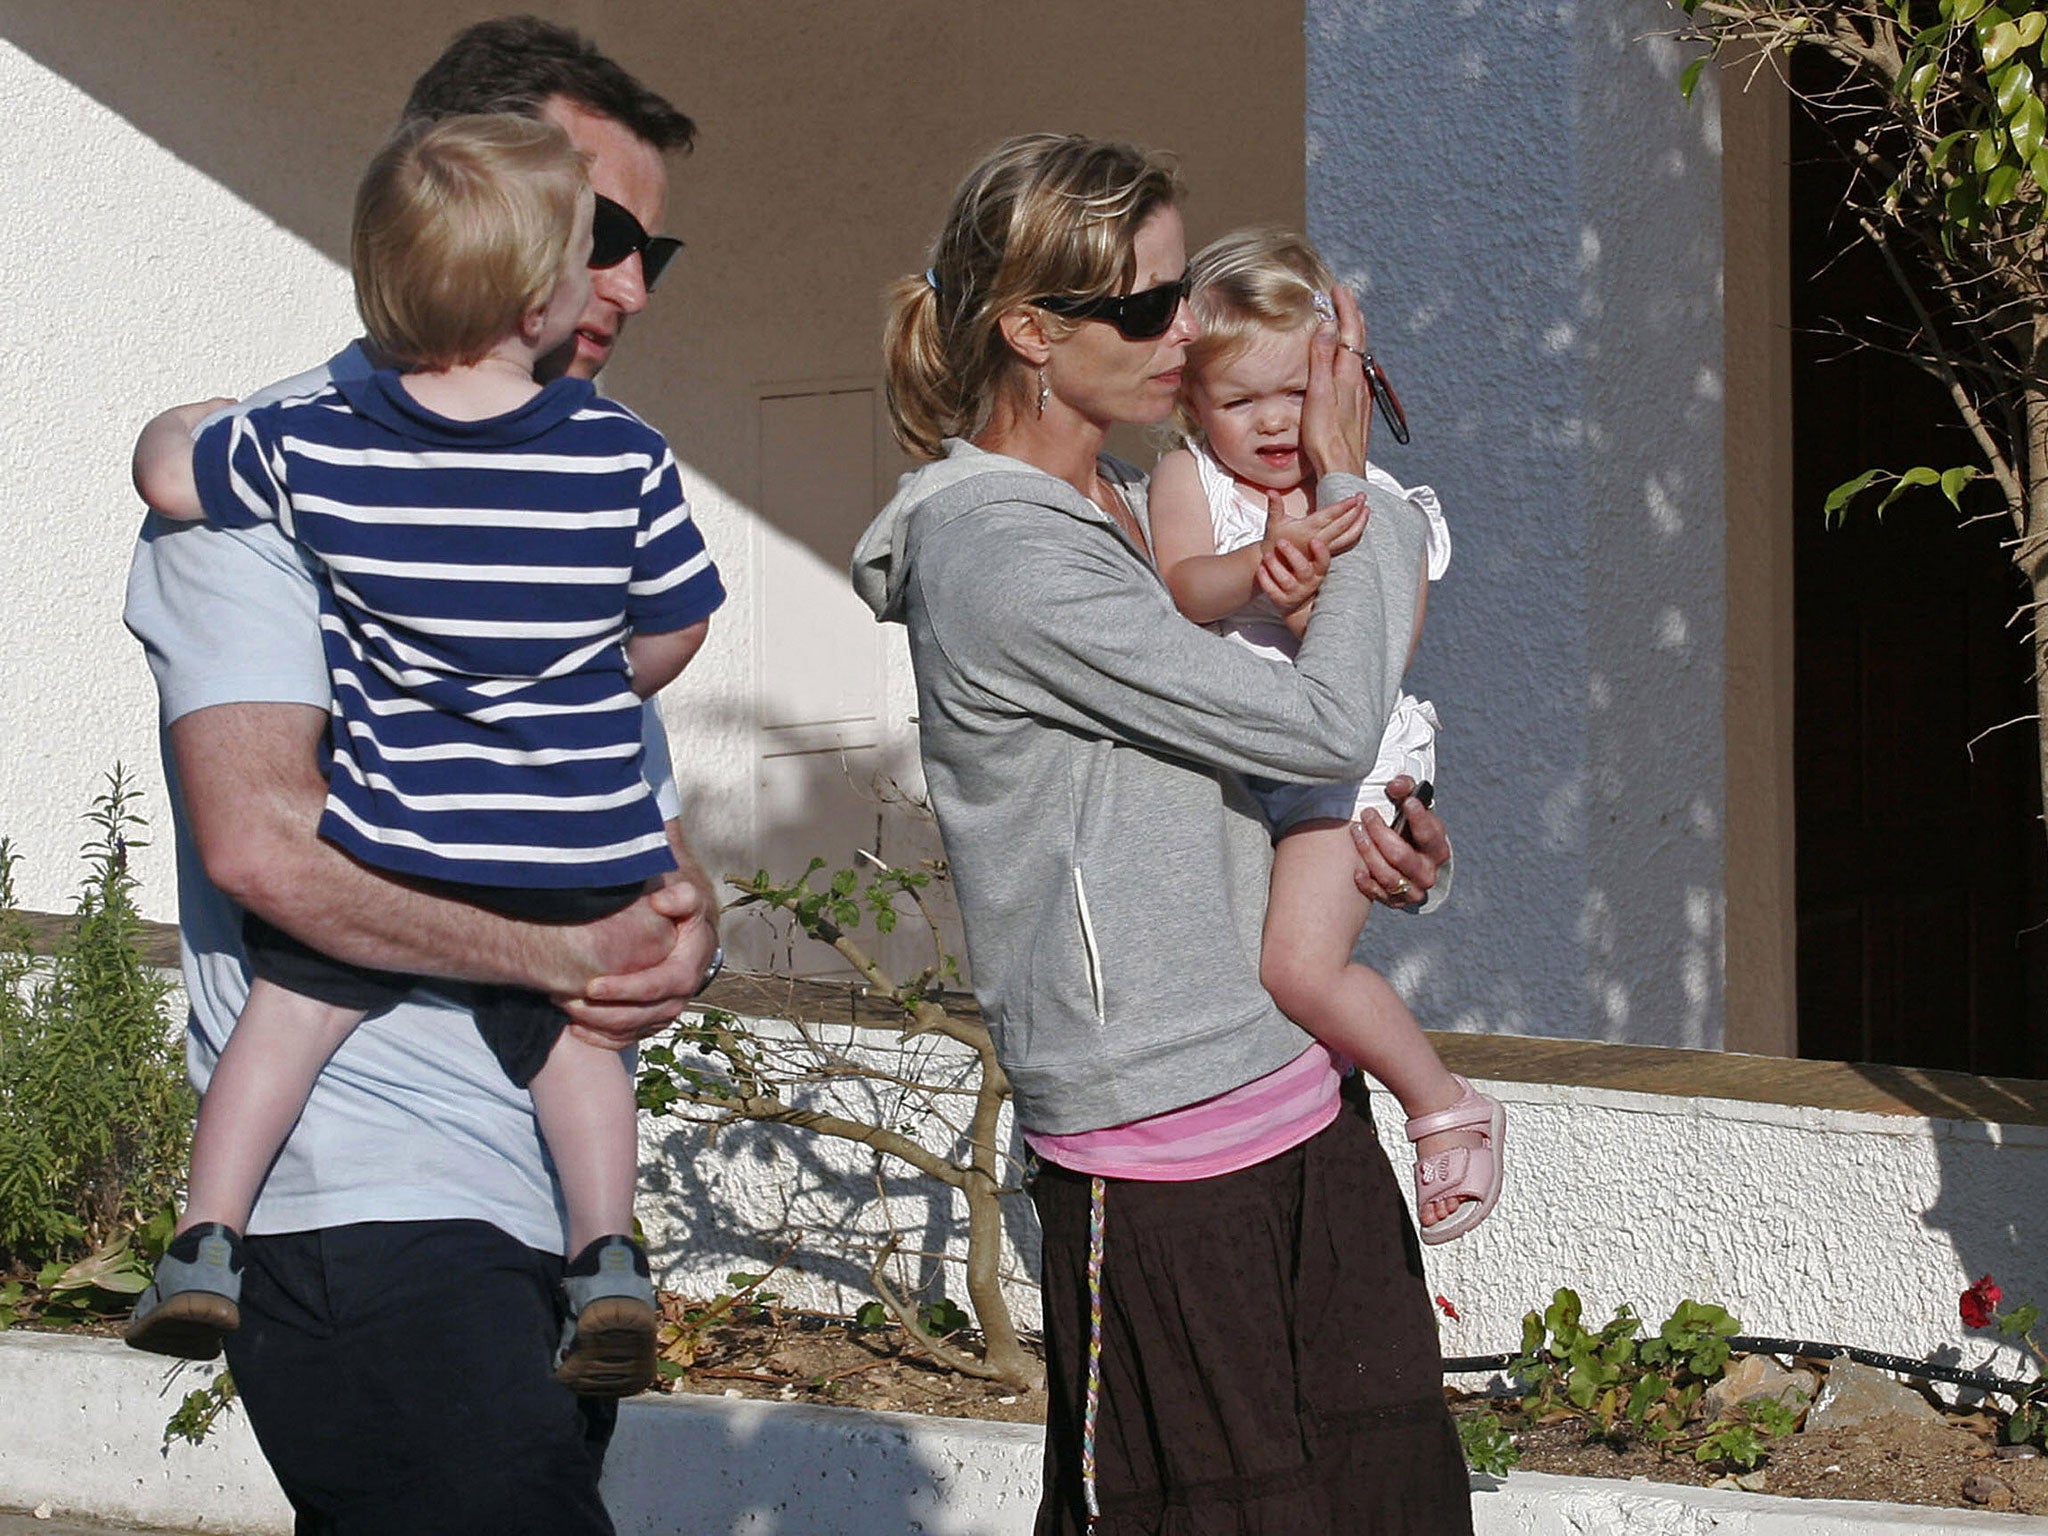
[852,440,1425,1135]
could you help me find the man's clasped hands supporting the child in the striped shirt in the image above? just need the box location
[557,823,719,1051]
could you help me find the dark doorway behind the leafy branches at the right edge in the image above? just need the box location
[1794,51,2048,1077]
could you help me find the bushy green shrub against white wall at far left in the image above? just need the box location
[0,766,193,1274]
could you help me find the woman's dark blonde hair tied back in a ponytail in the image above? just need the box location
[883,133,1182,459]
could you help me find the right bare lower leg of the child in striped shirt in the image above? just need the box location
[532,1030,639,1255]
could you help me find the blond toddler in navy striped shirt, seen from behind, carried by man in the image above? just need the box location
[127,115,725,1397]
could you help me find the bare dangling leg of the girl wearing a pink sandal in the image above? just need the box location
[1260,819,1485,1227]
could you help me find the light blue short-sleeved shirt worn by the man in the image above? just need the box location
[125,346,678,1251]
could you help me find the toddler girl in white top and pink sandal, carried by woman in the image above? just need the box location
[1151,231,1503,1243]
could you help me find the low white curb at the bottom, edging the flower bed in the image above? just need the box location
[0,1333,2048,1536]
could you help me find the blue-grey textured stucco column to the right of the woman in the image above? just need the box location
[1307,0,1726,1047]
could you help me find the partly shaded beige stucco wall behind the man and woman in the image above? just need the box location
[0,0,1303,974]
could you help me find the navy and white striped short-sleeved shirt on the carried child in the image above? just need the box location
[193,371,725,887]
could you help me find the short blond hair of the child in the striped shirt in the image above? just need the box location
[348,113,590,369]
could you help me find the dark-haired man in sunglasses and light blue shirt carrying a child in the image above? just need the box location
[127,16,717,1536]
